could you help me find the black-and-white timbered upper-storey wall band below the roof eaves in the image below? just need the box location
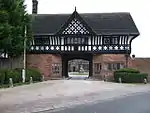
[30,35,134,54]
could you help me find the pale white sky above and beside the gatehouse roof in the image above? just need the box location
[25,0,150,57]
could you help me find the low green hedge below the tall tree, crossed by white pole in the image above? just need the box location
[0,69,42,85]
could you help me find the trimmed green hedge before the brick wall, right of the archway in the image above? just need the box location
[114,69,148,83]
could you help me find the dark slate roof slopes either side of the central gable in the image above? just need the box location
[32,13,139,35]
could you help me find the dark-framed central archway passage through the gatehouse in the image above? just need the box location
[62,53,93,77]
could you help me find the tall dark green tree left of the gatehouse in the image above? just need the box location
[0,0,31,58]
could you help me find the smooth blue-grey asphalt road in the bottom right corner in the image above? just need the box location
[42,92,150,113]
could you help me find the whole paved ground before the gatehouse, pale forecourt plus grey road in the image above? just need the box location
[0,79,150,113]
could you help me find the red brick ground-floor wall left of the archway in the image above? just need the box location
[27,54,61,79]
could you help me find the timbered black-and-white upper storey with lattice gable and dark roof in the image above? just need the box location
[29,10,139,54]
